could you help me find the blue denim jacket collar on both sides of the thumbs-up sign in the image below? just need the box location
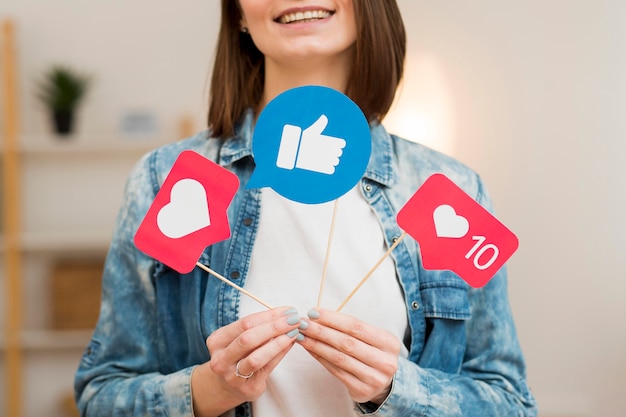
[219,109,395,186]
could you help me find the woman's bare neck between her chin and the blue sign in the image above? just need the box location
[259,54,350,110]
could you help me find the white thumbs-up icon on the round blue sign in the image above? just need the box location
[276,114,346,175]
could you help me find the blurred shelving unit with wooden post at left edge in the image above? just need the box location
[0,21,112,417]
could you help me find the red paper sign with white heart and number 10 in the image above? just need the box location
[397,174,519,288]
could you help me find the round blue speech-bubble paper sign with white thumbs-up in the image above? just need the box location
[247,86,372,204]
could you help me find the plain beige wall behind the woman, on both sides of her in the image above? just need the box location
[0,0,626,417]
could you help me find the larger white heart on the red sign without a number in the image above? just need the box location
[157,178,211,239]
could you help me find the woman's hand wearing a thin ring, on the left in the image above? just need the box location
[191,307,300,417]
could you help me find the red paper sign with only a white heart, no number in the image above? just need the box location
[135,151,239,274]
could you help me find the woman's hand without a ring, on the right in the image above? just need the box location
[300,309,401,404]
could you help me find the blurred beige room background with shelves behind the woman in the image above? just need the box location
[0,0,626,417]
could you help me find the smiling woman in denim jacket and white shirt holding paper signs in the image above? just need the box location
[76,0,536,417]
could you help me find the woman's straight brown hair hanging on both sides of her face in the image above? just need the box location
[208,0,406,138]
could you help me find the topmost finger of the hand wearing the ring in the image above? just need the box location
[207,307,297,353]
